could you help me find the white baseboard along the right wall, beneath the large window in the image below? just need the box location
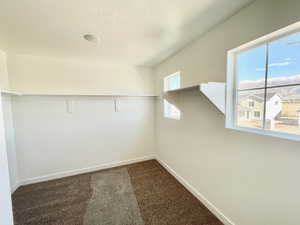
[156,158,235,225]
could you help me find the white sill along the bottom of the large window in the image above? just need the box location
[226,126,300,141]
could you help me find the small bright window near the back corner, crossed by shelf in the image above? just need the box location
[164,72,181,120]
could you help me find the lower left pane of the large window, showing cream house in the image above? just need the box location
[236,89,264,129]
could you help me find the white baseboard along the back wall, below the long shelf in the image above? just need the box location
[18,155,155,187]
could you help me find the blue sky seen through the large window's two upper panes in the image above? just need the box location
[238,33,300,81]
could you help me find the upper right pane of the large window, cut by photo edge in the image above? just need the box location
[268,33,300,86]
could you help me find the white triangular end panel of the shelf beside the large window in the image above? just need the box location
[200,82,226,114]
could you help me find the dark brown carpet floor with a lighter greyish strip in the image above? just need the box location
[12,160,222,225]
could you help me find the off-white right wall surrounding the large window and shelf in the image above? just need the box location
[155,0,300,225]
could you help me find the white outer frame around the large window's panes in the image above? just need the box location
[225,22,300,141]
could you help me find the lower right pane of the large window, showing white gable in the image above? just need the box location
[265,85,300,134]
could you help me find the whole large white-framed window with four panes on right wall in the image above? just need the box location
[226,23,300,140]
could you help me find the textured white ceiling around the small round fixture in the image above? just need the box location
[0,0,253,66]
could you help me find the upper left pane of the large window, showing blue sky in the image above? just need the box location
[237,45,266,90]
